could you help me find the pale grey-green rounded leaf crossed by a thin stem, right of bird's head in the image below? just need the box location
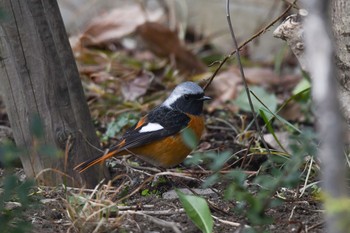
[234,86,278,119]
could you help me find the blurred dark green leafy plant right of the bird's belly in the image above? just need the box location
[185,105,317,231]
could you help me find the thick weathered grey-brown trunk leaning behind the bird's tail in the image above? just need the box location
[0,0,107,187]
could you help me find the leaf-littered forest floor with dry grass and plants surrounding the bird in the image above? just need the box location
[0,2,324,233]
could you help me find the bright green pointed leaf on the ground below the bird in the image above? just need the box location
[176,190,214,233]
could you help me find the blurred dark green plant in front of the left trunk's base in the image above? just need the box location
[0,115,60,233]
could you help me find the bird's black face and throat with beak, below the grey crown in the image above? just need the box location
[171,93,211,115]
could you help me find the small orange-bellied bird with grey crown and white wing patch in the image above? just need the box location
[74,81,211,173]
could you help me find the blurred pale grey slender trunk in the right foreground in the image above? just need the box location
[304,0,349,233]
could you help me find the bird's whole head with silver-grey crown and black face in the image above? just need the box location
[162,82,210,115]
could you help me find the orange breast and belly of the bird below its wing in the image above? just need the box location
[126,115,204,168]
